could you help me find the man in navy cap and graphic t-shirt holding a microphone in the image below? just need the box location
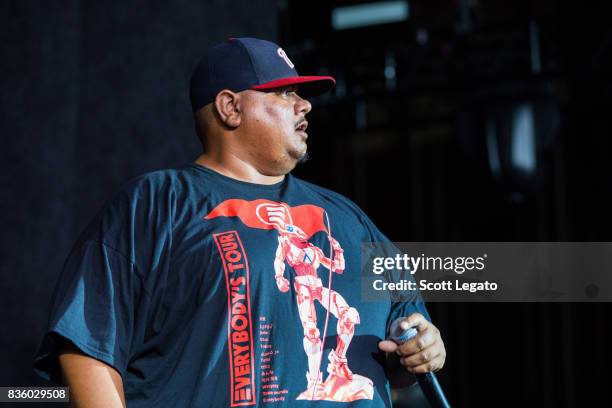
[36,38,445,407]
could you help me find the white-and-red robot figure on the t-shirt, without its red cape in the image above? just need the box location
[256,203,374,402]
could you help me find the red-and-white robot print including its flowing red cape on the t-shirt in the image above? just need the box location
[205,199,374,402]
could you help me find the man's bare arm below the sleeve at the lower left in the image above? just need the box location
[59,342,125,408]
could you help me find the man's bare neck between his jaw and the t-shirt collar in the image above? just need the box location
[195,152,285,185]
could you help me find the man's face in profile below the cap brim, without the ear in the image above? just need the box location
[234,86,311,175]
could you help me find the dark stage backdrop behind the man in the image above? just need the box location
[0,0,612,407]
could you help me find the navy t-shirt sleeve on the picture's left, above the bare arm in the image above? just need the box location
[34,240,144,382]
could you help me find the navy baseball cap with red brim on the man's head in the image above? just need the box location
[190,38,336,112]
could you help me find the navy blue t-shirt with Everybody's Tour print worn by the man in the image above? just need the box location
[35,164,427,408]
